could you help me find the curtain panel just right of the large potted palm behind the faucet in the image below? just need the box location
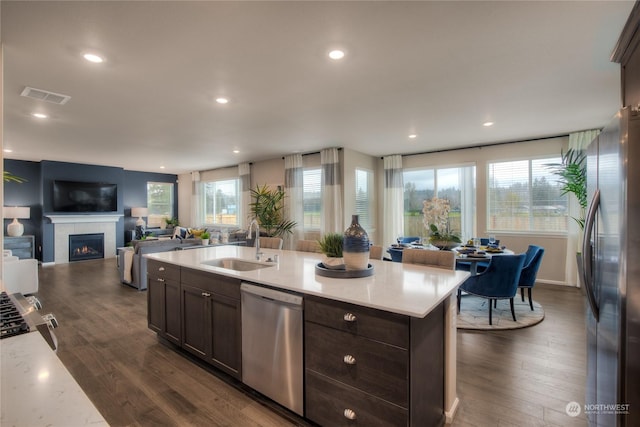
[283,154,304,249]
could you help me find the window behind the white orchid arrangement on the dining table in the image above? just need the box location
[402,165,476,240]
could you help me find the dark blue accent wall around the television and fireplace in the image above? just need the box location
[4,159,178,262]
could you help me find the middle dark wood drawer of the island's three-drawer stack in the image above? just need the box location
[305,322,409,408]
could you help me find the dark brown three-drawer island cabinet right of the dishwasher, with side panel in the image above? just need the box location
[305,297,444,427]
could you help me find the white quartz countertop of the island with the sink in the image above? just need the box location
[145,246,469,318]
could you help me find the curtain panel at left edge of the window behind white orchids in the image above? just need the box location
[382,155,404,246]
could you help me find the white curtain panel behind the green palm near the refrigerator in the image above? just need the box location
[565,129,600,286]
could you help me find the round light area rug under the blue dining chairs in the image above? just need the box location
[457,295,544,330]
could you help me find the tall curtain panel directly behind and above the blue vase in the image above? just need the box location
[320,148,345,235]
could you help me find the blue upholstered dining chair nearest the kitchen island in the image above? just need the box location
[458,254,525,325]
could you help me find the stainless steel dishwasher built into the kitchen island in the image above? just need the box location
[240,283,304,415]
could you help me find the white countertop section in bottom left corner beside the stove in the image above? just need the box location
[0,332,108,427]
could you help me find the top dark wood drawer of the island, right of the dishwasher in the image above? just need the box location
[305,297,409,348]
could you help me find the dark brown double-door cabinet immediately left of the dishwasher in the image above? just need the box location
[182,269,242,378]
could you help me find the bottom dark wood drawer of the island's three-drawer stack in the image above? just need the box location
[305,370,409,427]
